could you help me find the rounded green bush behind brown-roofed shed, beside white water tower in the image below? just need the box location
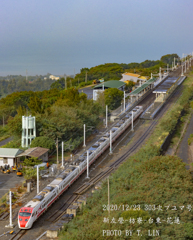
[30,136,56,150]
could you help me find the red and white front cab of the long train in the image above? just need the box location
[18,207,33,229]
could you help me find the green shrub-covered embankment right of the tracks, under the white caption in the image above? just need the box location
[60,73,193,240]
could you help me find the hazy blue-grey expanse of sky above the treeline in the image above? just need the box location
[0,0,193,76]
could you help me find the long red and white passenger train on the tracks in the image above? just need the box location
[18,106,143,229]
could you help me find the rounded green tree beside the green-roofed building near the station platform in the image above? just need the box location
[104,88,123,110]
